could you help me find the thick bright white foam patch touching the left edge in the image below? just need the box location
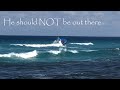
[0,50,38,59]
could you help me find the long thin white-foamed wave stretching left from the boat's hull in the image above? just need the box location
[10,44,65,47]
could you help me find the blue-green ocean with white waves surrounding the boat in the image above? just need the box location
[0,36,120,79]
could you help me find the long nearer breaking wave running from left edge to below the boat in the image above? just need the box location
[0,48,98,59]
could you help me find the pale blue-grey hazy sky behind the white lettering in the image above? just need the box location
[0,11,120,37]
